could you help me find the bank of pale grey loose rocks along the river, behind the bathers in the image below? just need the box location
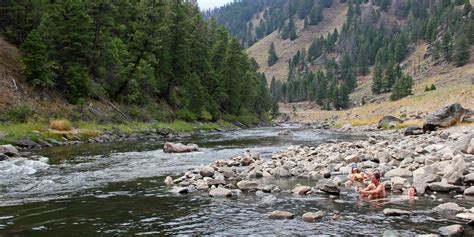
[165,104,474,234]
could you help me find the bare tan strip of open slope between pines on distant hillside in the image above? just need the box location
[247,1,347,81]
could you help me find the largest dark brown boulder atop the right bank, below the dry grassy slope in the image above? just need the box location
[423,103,466,131]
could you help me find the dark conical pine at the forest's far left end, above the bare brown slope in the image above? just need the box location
[21,30,54,87]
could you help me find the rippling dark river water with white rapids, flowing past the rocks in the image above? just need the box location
[0,127,474,236]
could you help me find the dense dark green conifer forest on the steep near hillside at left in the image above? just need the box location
[0,0,271,124]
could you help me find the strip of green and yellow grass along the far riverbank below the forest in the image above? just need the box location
[0,121,235,144]
